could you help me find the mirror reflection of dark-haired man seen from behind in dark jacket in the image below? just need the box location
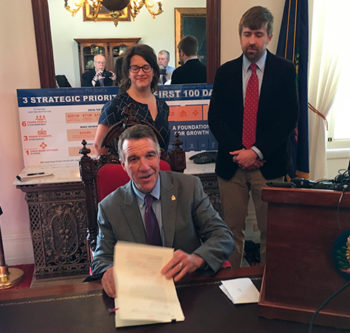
[171,36,207,84]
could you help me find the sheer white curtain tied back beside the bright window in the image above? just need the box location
[309,0,340,180]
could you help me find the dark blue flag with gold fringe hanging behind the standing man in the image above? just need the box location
[277,0,309,178]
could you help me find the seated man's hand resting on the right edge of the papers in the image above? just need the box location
[160,250,204,282]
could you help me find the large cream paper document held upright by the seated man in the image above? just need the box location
[114,241,185,327]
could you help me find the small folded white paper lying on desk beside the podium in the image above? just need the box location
[220,278,259,304]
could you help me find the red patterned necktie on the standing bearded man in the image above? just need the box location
[242,64,259,149]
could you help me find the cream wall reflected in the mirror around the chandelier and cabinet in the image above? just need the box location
[48,0,206,87]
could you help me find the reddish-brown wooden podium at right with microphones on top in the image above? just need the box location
[259,187,350,328]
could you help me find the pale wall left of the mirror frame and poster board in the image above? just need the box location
[0,0,40,264]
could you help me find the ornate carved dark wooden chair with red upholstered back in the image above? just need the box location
[79,104,186,251]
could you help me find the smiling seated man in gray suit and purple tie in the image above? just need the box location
[91,125,234,297]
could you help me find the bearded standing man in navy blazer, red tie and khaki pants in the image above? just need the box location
[208,6,298,267]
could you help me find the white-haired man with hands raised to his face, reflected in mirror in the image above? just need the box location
[81,54,116,87]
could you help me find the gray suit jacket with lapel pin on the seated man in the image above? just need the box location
[91,171,234,274]
